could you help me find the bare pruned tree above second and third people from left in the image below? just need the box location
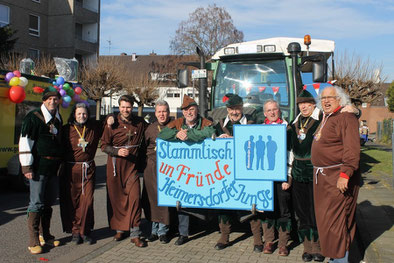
[81,57,125,119]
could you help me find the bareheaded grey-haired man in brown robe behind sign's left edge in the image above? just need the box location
[143,101,170,244]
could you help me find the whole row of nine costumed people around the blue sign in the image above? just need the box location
[19,86,360,262]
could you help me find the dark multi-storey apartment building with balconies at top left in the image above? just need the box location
[0,0,100,63]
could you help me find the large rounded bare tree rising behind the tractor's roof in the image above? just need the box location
[170,4,244,56]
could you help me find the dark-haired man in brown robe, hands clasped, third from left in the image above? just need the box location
[101,95,147,247]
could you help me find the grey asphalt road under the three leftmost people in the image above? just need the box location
[0,154,112,262]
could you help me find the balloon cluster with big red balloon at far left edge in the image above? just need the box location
[4,70,29,103]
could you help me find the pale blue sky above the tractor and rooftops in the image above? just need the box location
[100,0,394,82]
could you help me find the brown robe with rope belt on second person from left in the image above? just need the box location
[60,120,103,243]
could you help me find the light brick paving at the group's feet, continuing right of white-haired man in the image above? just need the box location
[74,147,394,263]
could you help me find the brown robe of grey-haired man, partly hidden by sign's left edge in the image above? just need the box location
[144,121,170,225]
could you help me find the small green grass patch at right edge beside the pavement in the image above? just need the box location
[360,146,393,175]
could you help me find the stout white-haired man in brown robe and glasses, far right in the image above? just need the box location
[312,86,360,262]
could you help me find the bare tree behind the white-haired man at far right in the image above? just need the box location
[334,52,385,105]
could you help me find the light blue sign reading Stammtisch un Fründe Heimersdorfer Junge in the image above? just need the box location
[156,125,287,211]
